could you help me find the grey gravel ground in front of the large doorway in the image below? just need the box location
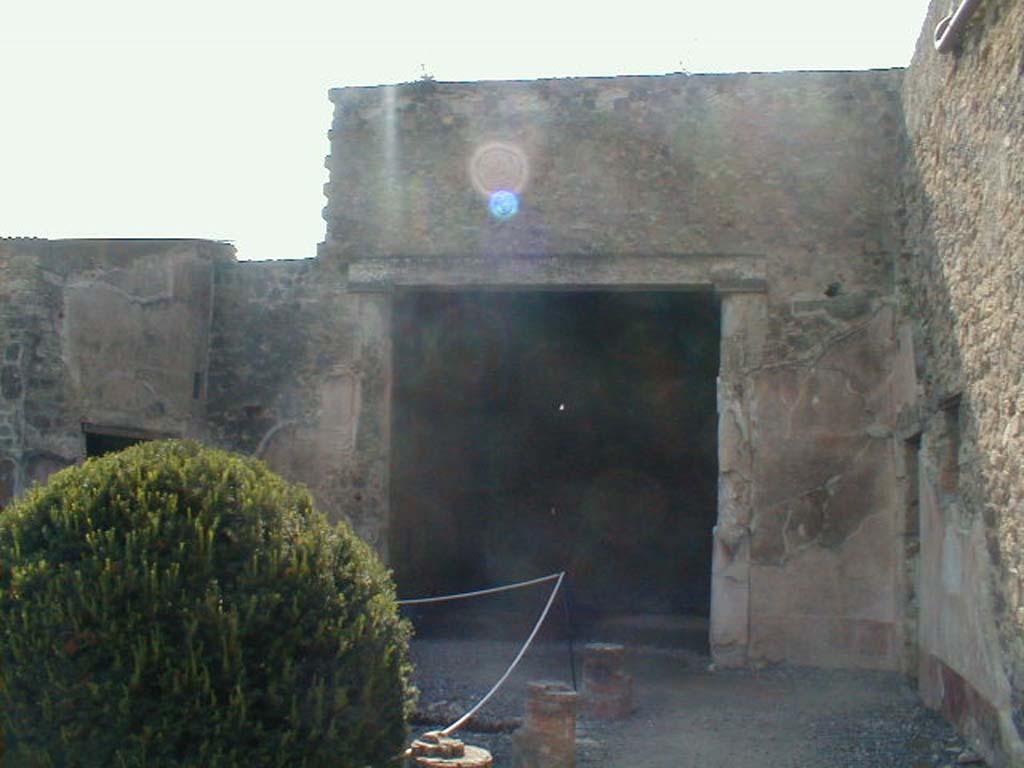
[413,639,984,768]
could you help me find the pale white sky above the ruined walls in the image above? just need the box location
[0,0,928,259]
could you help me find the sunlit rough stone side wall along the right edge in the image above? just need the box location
[897,0,1024,765]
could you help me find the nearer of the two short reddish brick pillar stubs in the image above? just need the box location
[513,683,579,768]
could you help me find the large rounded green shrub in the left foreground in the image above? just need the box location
[0,440,412,768]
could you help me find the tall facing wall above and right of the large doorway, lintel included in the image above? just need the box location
[322,72,904,668]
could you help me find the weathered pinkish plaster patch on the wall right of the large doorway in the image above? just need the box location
[749,306,901,669]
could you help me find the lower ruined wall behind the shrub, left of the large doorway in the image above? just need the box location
[0,239,390,552]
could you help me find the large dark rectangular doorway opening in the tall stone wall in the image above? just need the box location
[390,291,720,634]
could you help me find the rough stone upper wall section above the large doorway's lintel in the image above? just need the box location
[322,71,902,286]
